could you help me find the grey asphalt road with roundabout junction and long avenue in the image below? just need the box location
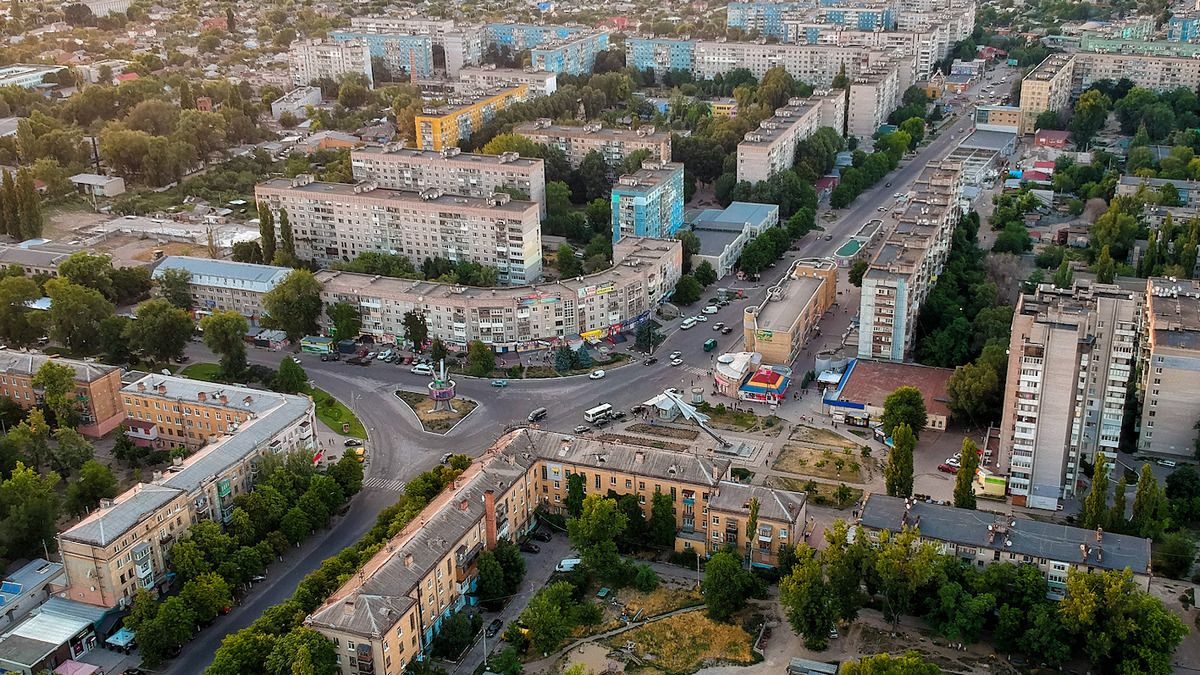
[162,64,1003,675]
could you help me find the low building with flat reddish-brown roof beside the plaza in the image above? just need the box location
[822,358,954,431]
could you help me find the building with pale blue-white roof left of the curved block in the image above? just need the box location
[151,256,292,325]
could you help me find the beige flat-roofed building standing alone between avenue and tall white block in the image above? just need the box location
[742,258,838,366]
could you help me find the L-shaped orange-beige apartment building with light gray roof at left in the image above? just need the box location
[58,375,316,608]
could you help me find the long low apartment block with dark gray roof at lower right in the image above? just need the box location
[859,494,1151,599]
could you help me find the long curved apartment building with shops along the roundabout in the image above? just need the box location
[317,237,683,352]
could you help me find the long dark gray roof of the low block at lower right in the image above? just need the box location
[862,494,1150,574]
